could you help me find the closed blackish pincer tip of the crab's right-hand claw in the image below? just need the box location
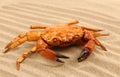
[78,48,90,62]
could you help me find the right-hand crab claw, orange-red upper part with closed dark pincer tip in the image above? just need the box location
[78,40,95,62]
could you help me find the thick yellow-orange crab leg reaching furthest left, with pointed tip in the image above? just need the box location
[4,31,41,53]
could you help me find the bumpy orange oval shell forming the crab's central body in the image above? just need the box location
[41,25,83,47]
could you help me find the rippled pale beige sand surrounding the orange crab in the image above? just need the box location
[0,0,120,77]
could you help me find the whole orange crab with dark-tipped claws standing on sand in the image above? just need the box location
[4,20,109,70]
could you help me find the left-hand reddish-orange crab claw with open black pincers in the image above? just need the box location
[37,39,69,63]
